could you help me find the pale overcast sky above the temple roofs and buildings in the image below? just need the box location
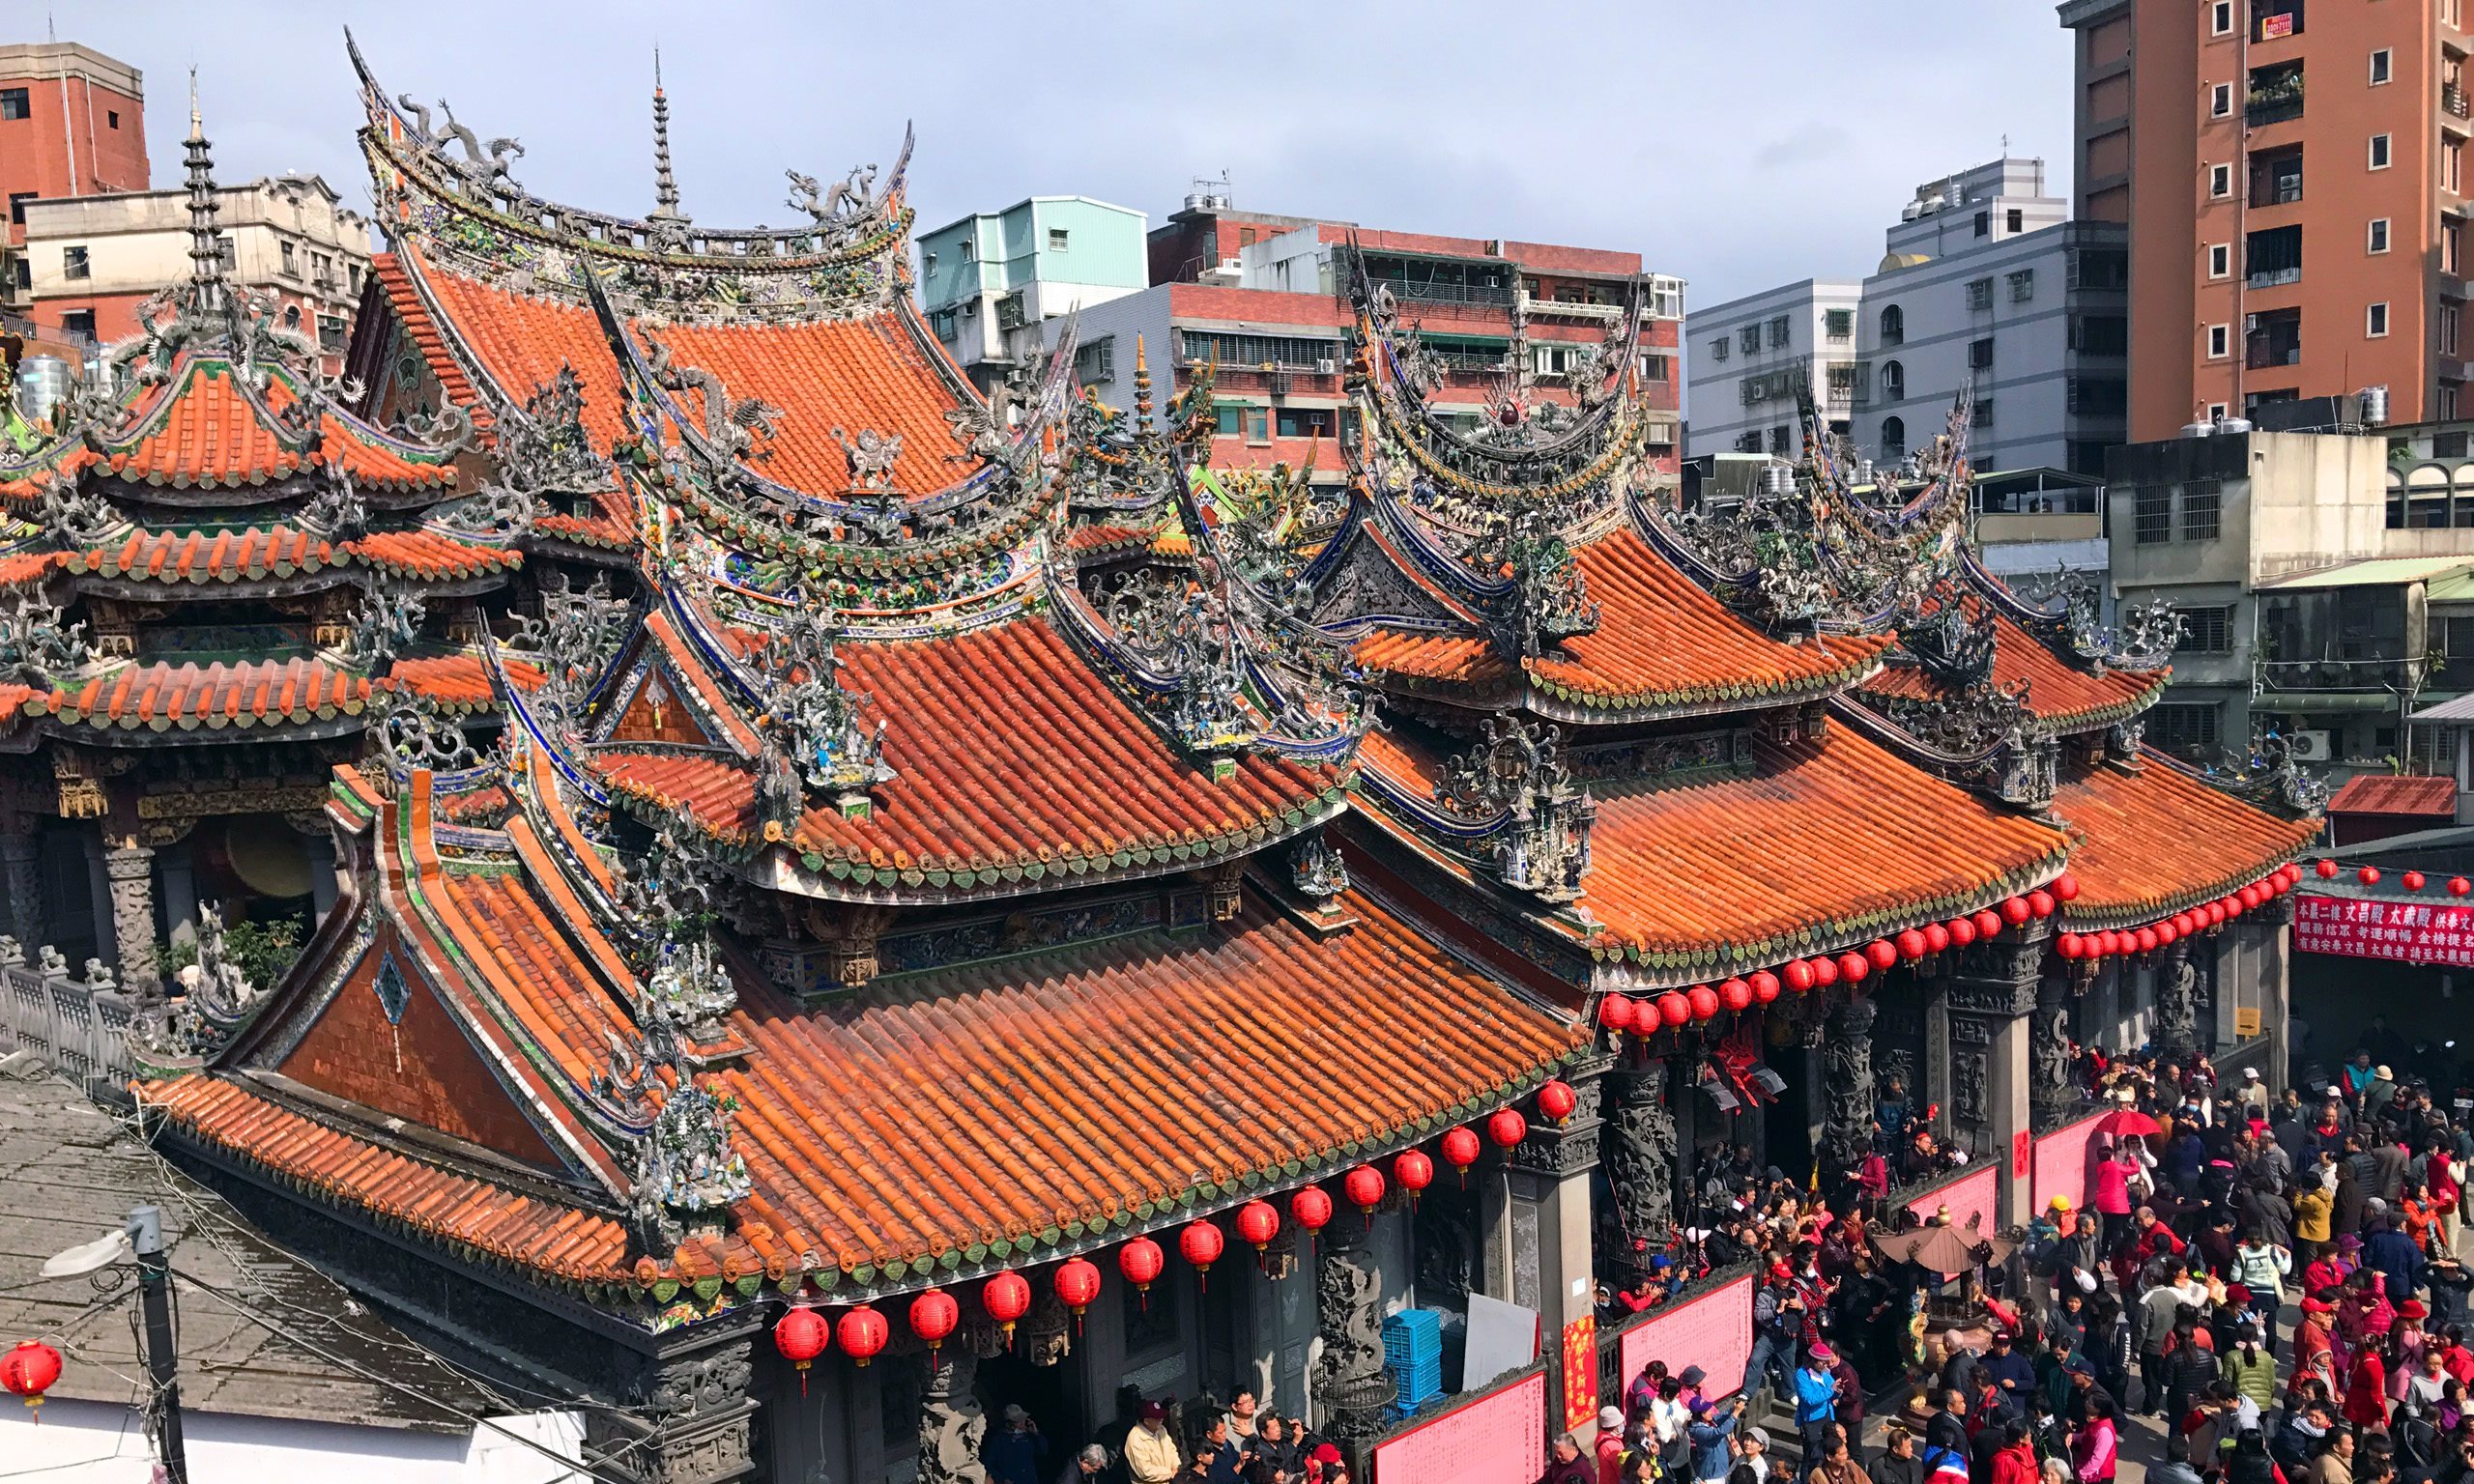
[53,0,2071,304]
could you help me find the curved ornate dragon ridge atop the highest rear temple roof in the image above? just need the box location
[346,32,913,322]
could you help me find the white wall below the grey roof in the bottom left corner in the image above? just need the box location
[0,1400,591,1484]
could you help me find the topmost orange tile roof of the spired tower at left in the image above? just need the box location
[104,361,455,490]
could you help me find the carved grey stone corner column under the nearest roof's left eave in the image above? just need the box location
[584,1328,757,1484]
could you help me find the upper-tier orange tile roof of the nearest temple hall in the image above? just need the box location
[589,618,1341,888]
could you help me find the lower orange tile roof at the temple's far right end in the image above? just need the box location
[2054,752,2318,928]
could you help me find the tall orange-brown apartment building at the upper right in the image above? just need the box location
[2060,0,2474,441]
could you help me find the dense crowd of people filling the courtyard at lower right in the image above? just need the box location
[1546,1048,2474,1484]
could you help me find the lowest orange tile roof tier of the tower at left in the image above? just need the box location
[30,661,368,732]
